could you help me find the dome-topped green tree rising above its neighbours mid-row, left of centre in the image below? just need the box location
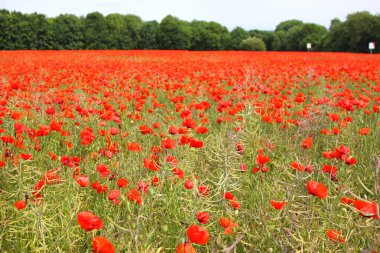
[158,15,191,49]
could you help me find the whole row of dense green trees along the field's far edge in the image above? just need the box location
[0,9,380,52]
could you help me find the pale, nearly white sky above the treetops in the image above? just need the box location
[0,0,380,30]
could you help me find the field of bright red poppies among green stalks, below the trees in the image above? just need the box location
[0,51,380,253]
